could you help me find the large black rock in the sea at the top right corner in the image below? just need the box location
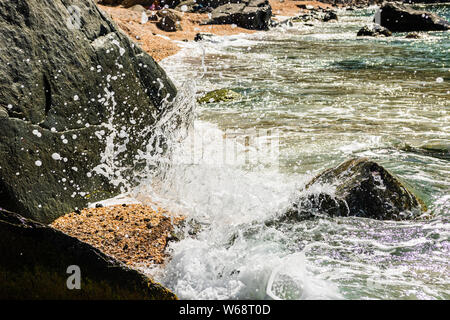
[380,3,450,32]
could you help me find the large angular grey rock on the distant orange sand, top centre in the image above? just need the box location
[207,0,272,30]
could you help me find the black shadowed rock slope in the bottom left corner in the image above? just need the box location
[0,209,176,300]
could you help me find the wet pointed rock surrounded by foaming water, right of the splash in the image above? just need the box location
[269,158,426,224]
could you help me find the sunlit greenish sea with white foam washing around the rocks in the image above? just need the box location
[152,6,450,299]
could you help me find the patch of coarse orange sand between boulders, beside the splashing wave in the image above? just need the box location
[51,204,183,267]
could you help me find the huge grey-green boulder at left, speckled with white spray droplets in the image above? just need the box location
[0,0,177,223]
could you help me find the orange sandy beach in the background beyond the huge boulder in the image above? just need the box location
[98,0,331,61]
